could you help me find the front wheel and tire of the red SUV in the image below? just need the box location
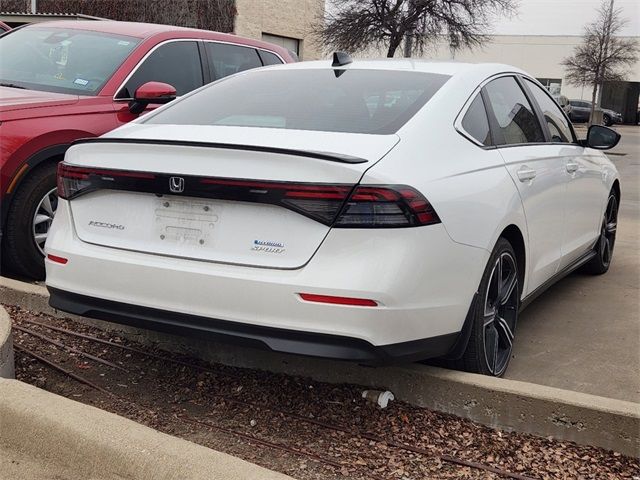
[2,162,58,280]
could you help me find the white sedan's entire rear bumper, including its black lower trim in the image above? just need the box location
[45,200,489,362]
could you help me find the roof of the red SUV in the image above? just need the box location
[18,20,286,53]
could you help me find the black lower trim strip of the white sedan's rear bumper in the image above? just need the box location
[49,287,459,365]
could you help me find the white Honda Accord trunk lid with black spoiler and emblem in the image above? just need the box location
[65,126,398,269]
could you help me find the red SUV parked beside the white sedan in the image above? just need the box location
[0,21,293,279]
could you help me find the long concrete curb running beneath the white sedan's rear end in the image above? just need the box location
[0,277,640,457]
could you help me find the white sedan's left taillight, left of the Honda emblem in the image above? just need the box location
[58,162,156,200]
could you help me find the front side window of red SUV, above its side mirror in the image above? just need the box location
[118,42,204,98]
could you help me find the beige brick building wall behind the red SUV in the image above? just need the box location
[234,0,324,60]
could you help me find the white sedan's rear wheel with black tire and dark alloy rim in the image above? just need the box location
[457,238,521,377]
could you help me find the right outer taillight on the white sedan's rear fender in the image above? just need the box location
[334,185,440,228]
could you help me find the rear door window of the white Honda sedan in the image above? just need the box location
[485,77,545,145]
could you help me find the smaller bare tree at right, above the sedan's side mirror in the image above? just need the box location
[562,0,640,125]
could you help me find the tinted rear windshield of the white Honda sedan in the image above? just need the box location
[144,69,449,134]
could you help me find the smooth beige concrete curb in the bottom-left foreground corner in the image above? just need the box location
[0,379,292,480]
